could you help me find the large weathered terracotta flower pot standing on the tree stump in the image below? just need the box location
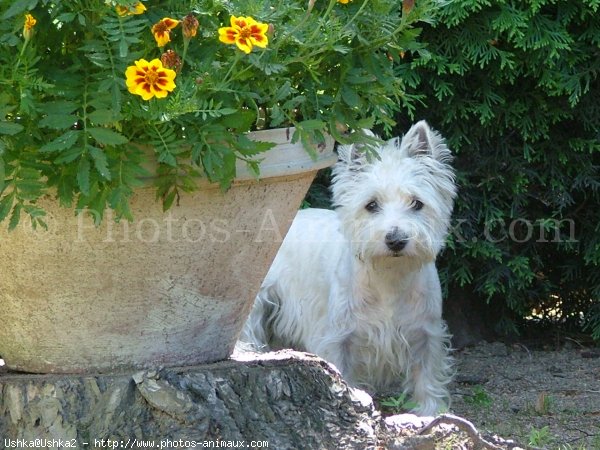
[0,129,335,373]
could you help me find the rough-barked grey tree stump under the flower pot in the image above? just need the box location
[0,351,516,450]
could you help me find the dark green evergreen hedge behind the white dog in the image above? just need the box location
[397,0,600,338]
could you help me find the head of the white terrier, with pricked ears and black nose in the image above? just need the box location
[332,121,456,262]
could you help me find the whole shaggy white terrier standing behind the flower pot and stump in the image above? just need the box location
[241,121,456,415]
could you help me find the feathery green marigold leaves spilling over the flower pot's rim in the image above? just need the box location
[0,0,433,227]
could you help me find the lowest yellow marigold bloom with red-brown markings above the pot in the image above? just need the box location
[125,59,176,100]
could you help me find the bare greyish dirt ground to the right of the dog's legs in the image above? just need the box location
[451,341,600,450]
